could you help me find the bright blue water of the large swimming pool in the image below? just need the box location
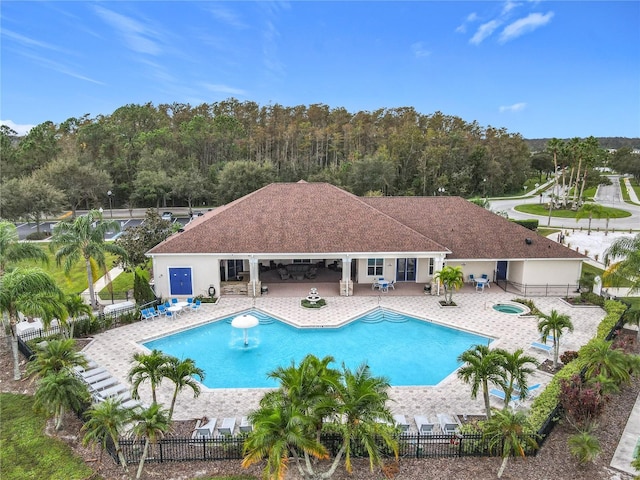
[144,309,491,388]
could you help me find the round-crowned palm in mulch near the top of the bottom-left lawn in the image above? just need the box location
[34,370,89,430]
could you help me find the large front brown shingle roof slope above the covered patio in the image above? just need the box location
[149,182,447,254]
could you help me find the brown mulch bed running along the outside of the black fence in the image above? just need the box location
[0,332,640,480]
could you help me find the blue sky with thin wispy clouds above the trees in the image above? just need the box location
[0,0,640,138]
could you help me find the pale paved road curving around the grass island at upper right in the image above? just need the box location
[489,176,640,230]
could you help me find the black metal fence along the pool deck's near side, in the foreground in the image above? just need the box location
[107,433,538,463]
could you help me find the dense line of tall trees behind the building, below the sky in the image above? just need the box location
[0,99,628,222]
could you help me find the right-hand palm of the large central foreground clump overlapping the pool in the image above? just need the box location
[328,364,398,474]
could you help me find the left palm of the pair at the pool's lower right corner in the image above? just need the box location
[458,345,506,418]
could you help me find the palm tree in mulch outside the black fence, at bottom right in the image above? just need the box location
[482,409,538,478]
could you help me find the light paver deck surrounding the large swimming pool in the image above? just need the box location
[84,290,605,428]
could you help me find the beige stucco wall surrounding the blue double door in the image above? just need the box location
[153,255,220,298]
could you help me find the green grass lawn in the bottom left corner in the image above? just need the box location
[0,393,96,480]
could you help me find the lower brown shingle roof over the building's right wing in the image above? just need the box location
[363,197,584,260]
